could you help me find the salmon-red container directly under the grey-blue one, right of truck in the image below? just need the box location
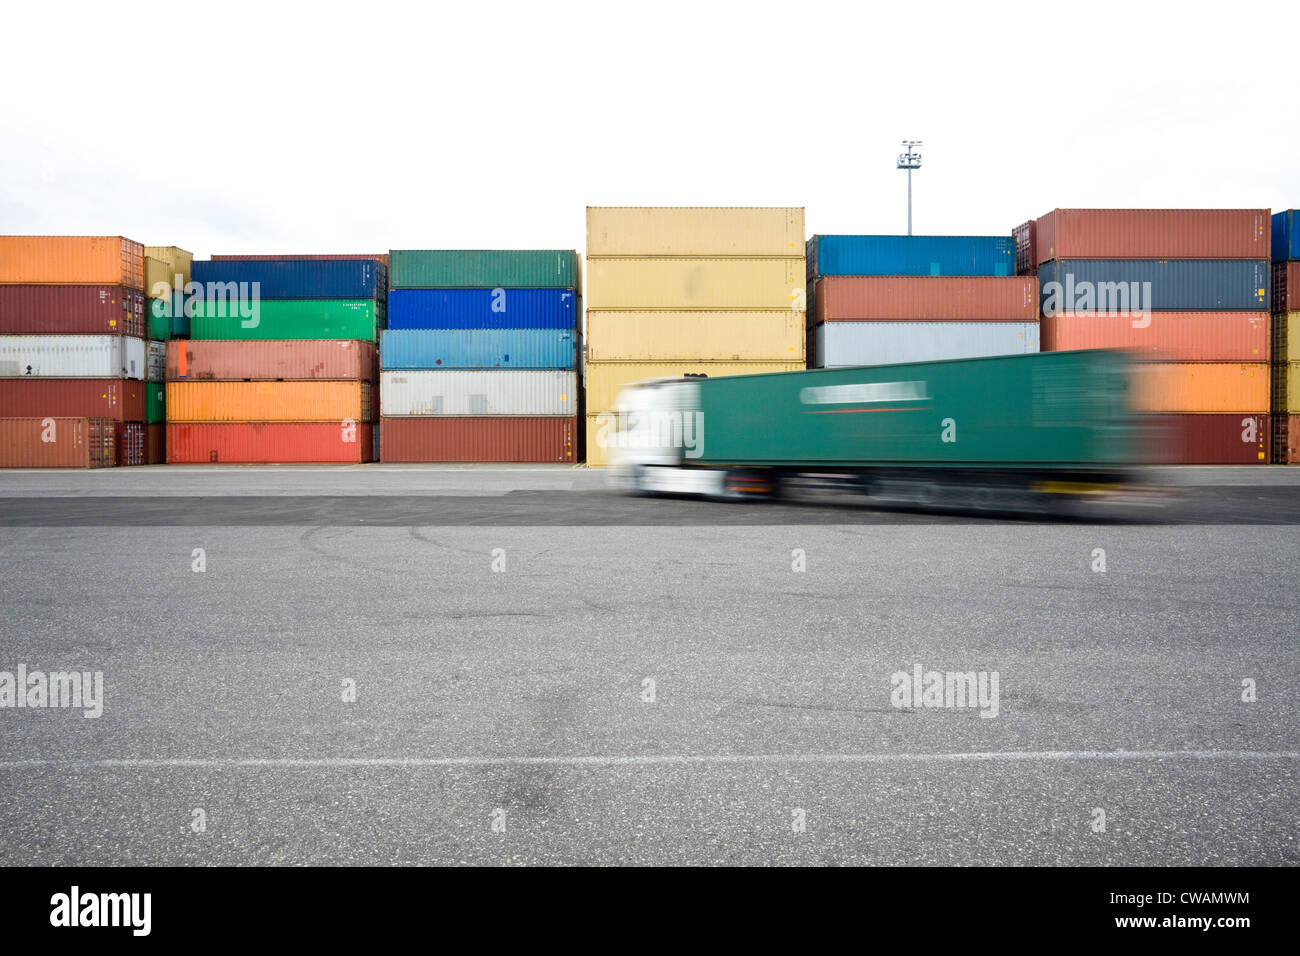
[1039,312,1270,362]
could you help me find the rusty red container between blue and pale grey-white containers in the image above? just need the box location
[813,276,1039,323]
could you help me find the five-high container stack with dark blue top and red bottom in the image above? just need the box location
[166,259,387,464]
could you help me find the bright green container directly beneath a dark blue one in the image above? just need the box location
[190,299,386,342]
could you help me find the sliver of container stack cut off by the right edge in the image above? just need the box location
[1271,209,1300,464]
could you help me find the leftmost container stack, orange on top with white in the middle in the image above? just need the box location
[0,235,148,467]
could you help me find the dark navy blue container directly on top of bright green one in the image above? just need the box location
[190,259,389,299]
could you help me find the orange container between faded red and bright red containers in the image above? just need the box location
[166,381,373,423]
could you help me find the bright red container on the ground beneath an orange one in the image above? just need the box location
[166,421,374,464]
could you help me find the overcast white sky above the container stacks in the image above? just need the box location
[0,0,1300,258]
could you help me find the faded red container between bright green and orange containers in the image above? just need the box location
[166,338,380,382]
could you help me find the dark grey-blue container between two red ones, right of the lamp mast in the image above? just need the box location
[1039,259,1269,315]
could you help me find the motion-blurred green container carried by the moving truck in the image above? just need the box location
[683,351,1136,467]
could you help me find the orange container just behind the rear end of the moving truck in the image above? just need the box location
[1133,352,1269,415]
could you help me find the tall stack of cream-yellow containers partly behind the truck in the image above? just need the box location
[584,207,806,466]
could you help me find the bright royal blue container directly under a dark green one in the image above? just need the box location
[389,289,581,330]
